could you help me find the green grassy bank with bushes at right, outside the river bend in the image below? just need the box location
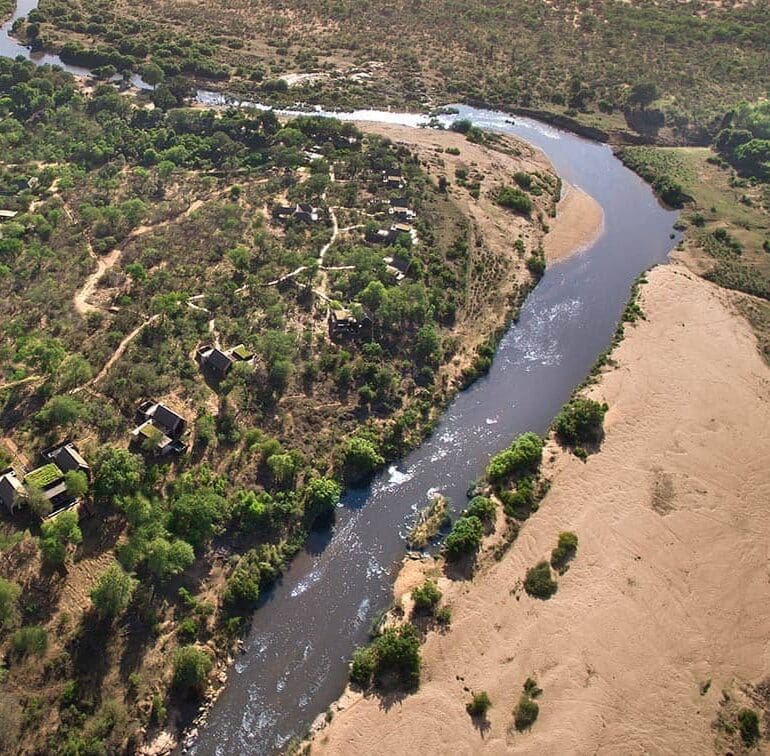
[619,100,770,361]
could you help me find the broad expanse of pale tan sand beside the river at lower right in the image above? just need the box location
[312,266,770,756]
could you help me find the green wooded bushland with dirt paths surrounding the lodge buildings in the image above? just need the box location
[0,60,556,753]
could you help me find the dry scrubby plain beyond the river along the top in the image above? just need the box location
[21,0,770,139]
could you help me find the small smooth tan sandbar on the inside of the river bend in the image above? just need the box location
[543,182,604,263]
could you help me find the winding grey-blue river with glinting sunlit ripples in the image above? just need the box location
[0,7,676,756]
